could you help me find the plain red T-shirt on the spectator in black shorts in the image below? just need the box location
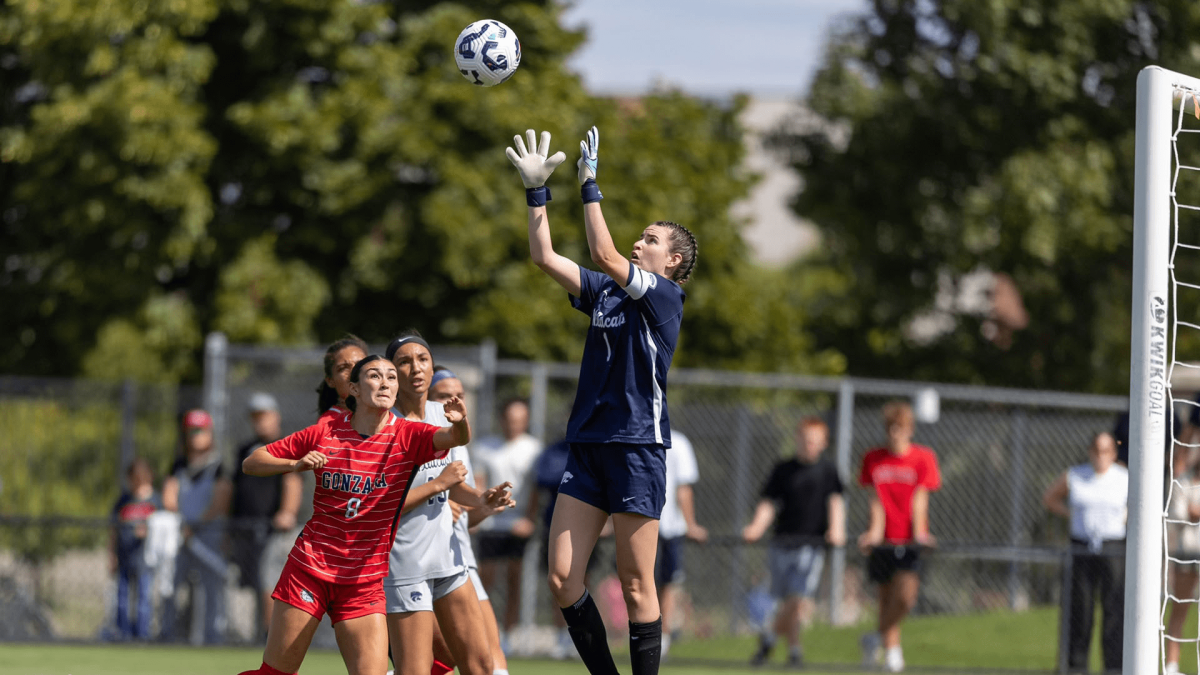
[858,443,942,544]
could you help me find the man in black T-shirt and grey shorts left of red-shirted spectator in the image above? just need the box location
[742,418,846,667]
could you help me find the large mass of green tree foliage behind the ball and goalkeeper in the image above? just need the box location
[0,0,841,378]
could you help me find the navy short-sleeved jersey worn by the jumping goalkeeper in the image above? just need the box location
[566,263,686,448]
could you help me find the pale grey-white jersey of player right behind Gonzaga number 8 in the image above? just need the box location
[384,401,467,586]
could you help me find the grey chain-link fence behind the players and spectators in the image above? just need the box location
[0,336,1127,668]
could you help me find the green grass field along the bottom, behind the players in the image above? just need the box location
[0,608,1196,675]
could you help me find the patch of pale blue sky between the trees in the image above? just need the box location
[564,0,866,97]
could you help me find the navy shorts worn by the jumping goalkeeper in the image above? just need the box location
[558,443,667,520]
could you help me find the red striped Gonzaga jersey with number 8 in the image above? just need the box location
[266,412,445,584]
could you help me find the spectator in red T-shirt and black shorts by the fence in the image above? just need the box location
[858,401,942,673]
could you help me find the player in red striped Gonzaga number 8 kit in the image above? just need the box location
[242,354,494,675]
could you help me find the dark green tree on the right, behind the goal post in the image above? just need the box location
[778,0,1200,393]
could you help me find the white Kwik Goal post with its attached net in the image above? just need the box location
[1123,67,1200,674]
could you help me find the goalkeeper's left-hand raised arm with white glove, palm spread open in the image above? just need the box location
[505,129,580,295]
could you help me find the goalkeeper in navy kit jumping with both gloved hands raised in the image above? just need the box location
[506,126,696,675]
